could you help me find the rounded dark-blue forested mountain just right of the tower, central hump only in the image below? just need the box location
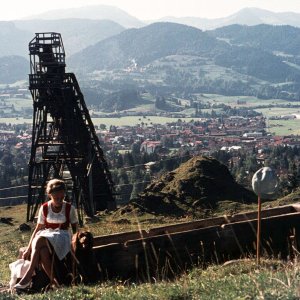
[69,23,230,72]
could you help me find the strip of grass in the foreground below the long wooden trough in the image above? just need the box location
[0,260,300,300]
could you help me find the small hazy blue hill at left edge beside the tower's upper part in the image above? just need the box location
[0,55,29,84]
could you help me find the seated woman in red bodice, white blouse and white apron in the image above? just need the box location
[15,179,78,290]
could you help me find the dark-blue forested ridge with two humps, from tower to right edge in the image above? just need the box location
[69,23,300,82]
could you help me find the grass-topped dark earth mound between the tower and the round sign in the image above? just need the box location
[130,156,256,217]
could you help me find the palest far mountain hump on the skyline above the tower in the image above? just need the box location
[27,5,145,28]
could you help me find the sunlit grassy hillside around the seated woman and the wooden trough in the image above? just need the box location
[0,193,300,300]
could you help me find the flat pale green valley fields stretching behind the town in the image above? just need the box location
[1,94,300,135]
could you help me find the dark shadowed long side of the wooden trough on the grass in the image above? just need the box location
[94,212,300,279]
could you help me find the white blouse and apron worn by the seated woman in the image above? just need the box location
[32,201,78,260]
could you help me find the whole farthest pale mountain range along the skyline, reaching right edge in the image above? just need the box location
[30,5,300,30]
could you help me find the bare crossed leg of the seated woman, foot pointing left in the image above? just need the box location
[19,237,51,285]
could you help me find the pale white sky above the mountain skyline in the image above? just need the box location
[0,0,300,21]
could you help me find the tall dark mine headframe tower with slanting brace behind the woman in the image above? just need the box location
[27,32,115,222]
